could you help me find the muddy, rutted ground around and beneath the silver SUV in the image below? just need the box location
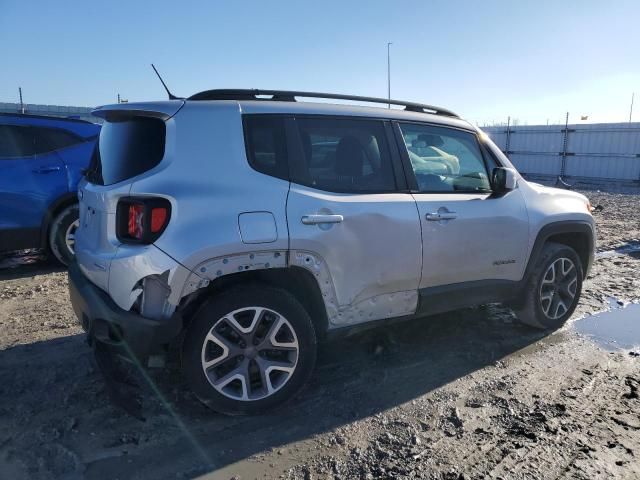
[0,188,640,479]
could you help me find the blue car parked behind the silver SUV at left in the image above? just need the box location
[0,113,100,265]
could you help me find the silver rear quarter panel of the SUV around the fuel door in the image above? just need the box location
[131,101,289,280]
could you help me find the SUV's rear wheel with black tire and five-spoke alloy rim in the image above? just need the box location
[182,284,317,415]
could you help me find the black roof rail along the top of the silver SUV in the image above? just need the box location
[187,89,458,117]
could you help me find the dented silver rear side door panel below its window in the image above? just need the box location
[287,184,422,326]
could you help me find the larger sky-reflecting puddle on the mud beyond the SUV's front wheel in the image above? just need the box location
[574,299,640,350]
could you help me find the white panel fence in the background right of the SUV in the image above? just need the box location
[483,123,640,180]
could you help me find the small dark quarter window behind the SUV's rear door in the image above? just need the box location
[244,115,289,180]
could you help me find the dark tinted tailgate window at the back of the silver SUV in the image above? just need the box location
[87,117,166,185]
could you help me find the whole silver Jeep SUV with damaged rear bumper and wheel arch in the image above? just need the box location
[69,90,595,414]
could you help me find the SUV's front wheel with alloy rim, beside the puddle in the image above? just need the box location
[515,242,583,330]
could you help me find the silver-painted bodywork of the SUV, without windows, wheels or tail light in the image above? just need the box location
[75,97,593,327]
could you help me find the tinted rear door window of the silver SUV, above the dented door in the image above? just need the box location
[291,118,396,193]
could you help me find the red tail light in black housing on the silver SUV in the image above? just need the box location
[116,198,171,244]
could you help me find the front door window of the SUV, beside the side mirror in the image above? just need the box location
[400,123,491,192]
